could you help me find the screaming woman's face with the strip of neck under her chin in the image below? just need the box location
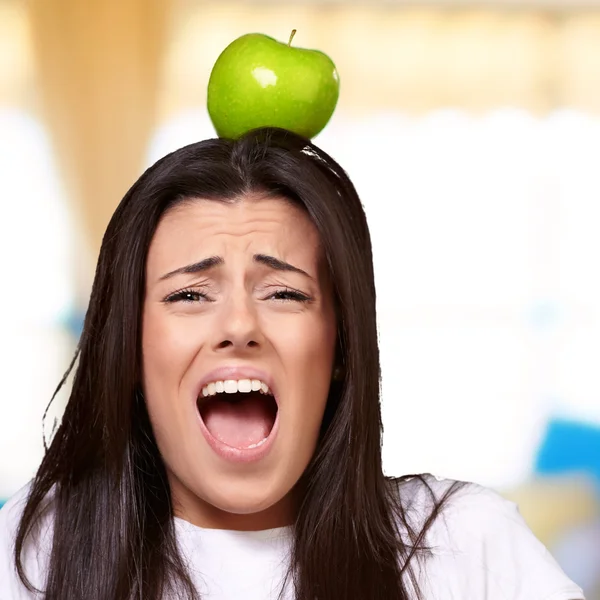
[142,196,336,529]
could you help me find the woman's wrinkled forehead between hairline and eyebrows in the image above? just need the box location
[148,196,321,271]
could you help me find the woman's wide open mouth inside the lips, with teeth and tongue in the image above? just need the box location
[197,379,278,450]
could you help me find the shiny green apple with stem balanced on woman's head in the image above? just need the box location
[208,30,340,138]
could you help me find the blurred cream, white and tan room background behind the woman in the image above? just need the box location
[0,0,600,600]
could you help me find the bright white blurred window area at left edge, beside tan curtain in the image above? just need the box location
[0,107,75,501]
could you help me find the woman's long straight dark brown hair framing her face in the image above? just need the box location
[15,128,460,600]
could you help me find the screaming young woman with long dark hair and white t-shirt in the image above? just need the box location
[0,129,583,600]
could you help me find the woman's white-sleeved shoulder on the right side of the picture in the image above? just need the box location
[398,476,583,600]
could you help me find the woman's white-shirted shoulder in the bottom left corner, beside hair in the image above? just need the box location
[0,484,52,600]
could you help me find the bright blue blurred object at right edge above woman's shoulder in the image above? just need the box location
[535,418,600,484]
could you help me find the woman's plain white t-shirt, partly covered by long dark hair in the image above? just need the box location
[0,477,584,600]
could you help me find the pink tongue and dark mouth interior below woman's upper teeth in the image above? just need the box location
[202,394,273,448]
